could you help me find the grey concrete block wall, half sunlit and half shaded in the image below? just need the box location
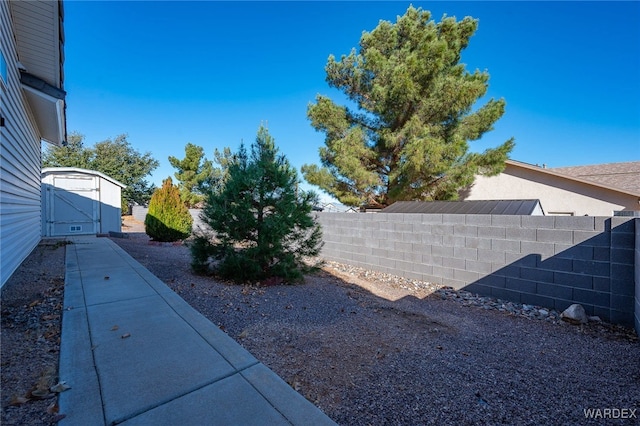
[318,213,640,325]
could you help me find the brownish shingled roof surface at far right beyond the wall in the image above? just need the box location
[551,161,640,193]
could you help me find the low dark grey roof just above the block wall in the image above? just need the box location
[381,200,541,215]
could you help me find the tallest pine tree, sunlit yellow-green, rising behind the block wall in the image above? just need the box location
[302,7,514,206]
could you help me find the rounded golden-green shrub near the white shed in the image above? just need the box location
[144,178,193,242]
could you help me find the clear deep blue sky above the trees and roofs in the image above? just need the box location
[65,0,640,198]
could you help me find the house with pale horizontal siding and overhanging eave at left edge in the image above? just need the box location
[0,0,66,286]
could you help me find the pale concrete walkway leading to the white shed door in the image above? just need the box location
[59,237,335,426]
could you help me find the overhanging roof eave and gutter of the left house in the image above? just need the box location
[9,0,67,145]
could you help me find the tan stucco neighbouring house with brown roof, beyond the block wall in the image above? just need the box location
[461,160,640,216]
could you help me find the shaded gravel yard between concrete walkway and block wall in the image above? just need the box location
[2,218,640,425]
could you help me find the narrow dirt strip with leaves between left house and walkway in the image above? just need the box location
[0,239,65,425]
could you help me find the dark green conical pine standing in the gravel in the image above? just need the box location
[191,127,322,283]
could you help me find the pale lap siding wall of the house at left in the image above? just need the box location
[0,1,41,286]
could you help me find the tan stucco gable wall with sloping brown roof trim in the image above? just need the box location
[463,161,640,216]
